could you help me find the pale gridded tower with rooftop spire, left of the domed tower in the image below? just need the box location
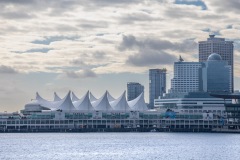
[170,56,202,93]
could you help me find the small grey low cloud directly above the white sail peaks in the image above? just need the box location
[65,69,97,79]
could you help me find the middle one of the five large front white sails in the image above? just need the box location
[92,92,113,111]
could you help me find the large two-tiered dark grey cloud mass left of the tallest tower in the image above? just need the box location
[118,35,197,67]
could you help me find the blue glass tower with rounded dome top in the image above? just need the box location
[200,53,232,92]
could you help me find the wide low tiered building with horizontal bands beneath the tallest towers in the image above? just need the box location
[154,92,232,118]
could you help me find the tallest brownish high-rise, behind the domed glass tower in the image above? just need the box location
[199,35,234,92]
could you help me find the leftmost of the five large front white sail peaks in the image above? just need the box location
[54,91,76,111]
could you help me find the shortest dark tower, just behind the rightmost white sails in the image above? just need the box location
[127,82,144,101]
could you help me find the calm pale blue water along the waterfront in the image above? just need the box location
[0,133,240,160]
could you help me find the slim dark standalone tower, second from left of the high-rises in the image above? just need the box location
[149,68,167,108]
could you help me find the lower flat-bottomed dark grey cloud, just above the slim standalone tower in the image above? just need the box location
[126,49,176,67]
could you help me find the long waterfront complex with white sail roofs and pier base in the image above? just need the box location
[0,92,236,132]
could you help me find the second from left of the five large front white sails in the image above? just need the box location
[73,91,94,111]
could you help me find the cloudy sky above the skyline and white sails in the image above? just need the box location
[0,0,240,112]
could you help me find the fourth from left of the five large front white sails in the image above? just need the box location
[110,91,131,111]
